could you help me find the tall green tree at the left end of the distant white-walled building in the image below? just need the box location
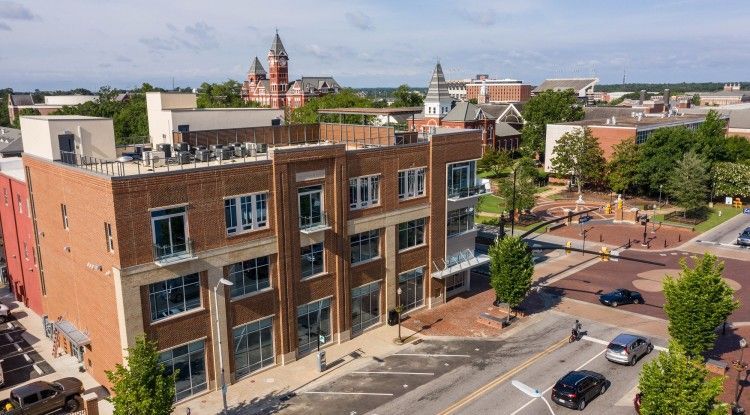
[521,89,584,157]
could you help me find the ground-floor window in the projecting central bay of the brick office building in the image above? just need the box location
[297,298,331,356]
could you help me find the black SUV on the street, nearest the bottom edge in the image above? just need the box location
[552,370,607,411]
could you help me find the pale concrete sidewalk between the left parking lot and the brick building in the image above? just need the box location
[0,287,113,415]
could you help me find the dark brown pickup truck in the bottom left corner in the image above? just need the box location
[0,378,83,415]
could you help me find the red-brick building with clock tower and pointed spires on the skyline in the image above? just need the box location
[242,31,341,109]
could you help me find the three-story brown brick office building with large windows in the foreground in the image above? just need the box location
[22,112,488,400]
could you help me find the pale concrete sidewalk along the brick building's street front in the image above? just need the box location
[173,324,418,415]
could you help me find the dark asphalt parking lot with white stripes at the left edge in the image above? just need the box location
[0,314,54,390]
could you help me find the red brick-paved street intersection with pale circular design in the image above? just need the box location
[547,250,750,321]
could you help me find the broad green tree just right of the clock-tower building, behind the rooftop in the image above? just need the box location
[287,88,373,124]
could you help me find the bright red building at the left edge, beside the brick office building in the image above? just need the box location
[0,157,43,315]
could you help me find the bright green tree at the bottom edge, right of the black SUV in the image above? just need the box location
[638,341,727,415]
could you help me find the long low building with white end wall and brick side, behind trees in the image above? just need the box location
[544,113,706,172]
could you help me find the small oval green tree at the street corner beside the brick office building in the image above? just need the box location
[489,236,534,309]
